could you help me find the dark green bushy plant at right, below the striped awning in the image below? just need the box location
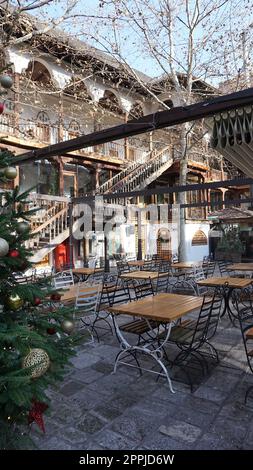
[215,226,245,262]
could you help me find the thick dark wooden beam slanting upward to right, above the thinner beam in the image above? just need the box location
[13,88,253,165]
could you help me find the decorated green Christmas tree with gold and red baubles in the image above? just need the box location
[0,150,77,449]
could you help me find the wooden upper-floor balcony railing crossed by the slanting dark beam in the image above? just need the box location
[0,113,147,162]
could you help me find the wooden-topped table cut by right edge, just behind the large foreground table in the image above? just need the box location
[197,276,252,323]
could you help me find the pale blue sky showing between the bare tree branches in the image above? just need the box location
[28,0,253,85]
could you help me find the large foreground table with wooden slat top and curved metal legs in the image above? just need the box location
[108,293,203,393]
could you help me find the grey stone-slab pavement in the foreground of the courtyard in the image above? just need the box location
[34,310,253,450]
